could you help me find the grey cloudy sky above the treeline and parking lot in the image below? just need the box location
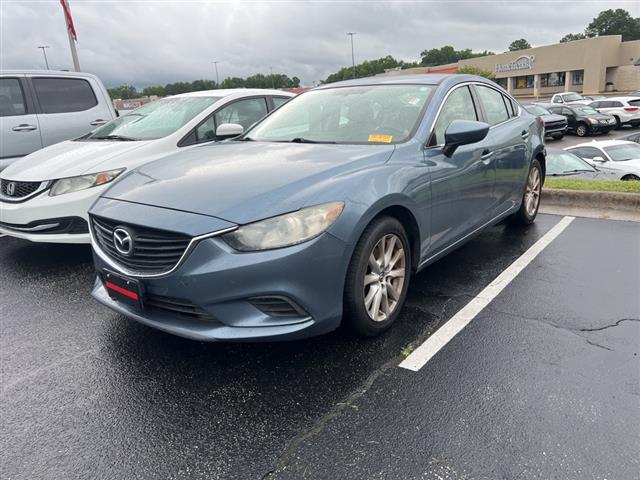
[0,0,640,87]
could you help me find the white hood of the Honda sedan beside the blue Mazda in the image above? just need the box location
[2,140,151,182]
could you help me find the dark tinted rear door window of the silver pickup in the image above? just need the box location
[33,78,98,113]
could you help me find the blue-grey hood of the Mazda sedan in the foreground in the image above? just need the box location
[103,142,395,224]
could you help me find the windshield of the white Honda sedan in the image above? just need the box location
[84,97,221,140]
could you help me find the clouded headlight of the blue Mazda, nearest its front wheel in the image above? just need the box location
[222,202,344,252]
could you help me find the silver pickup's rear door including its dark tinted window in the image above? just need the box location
[30,76,112,147]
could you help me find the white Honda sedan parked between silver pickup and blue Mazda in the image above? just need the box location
[0,89,294,243]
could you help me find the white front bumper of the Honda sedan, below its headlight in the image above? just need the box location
[0,186,106,243]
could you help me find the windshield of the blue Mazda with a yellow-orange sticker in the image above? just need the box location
[244,85,435,143]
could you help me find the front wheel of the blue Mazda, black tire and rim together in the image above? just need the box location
[344,217,411,337]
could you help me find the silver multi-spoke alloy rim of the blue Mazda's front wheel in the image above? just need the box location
[364,233,406,322]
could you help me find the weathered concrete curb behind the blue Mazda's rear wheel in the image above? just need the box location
[542,188,640,213]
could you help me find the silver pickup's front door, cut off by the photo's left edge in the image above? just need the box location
[0,76,42,165]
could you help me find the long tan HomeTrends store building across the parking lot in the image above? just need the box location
[387,35,640,97]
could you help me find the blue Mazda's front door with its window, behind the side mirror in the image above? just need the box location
[424,85,496,254]
